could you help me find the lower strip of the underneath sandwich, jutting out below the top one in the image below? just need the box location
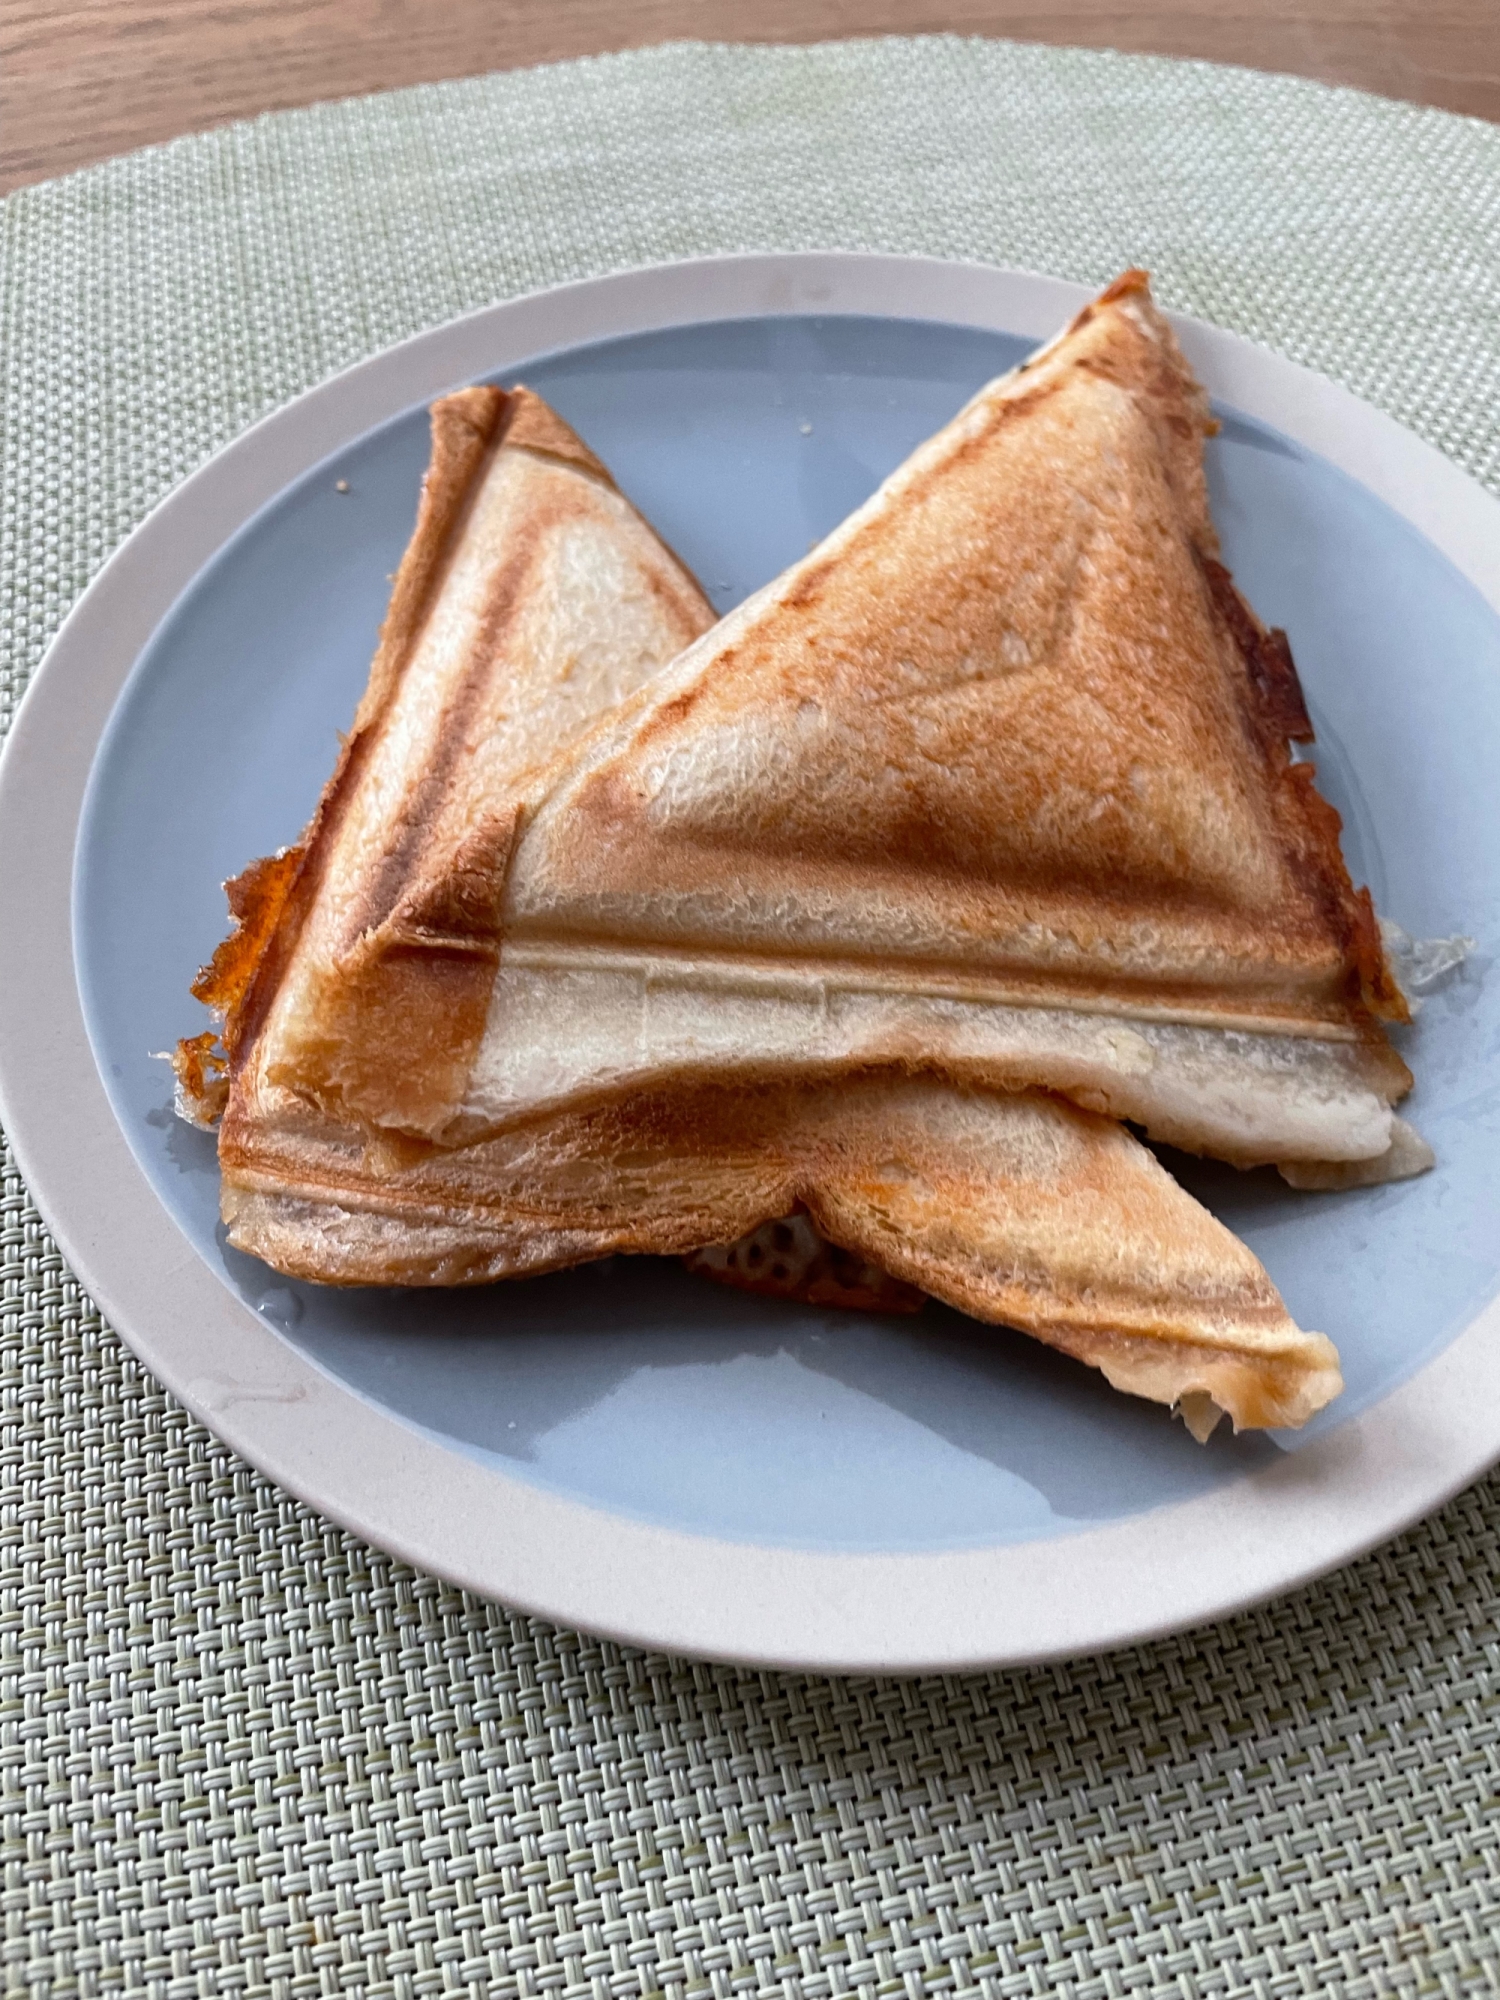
[220,1072,1340,1428]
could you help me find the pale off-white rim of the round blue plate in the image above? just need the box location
[0,252,1500,1672]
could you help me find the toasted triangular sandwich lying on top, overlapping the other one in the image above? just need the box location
[264,272,1410,1170]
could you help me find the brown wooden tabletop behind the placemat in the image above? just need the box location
[0,0,1500,188]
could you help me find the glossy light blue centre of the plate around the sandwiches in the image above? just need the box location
[74,316,1500,1550]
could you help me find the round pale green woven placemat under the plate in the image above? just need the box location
[0,40,1500,2000]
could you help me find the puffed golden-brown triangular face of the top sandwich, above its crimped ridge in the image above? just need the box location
[504,276,1404,1032]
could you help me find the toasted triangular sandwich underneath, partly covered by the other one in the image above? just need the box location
[178,376,1338,1430]
